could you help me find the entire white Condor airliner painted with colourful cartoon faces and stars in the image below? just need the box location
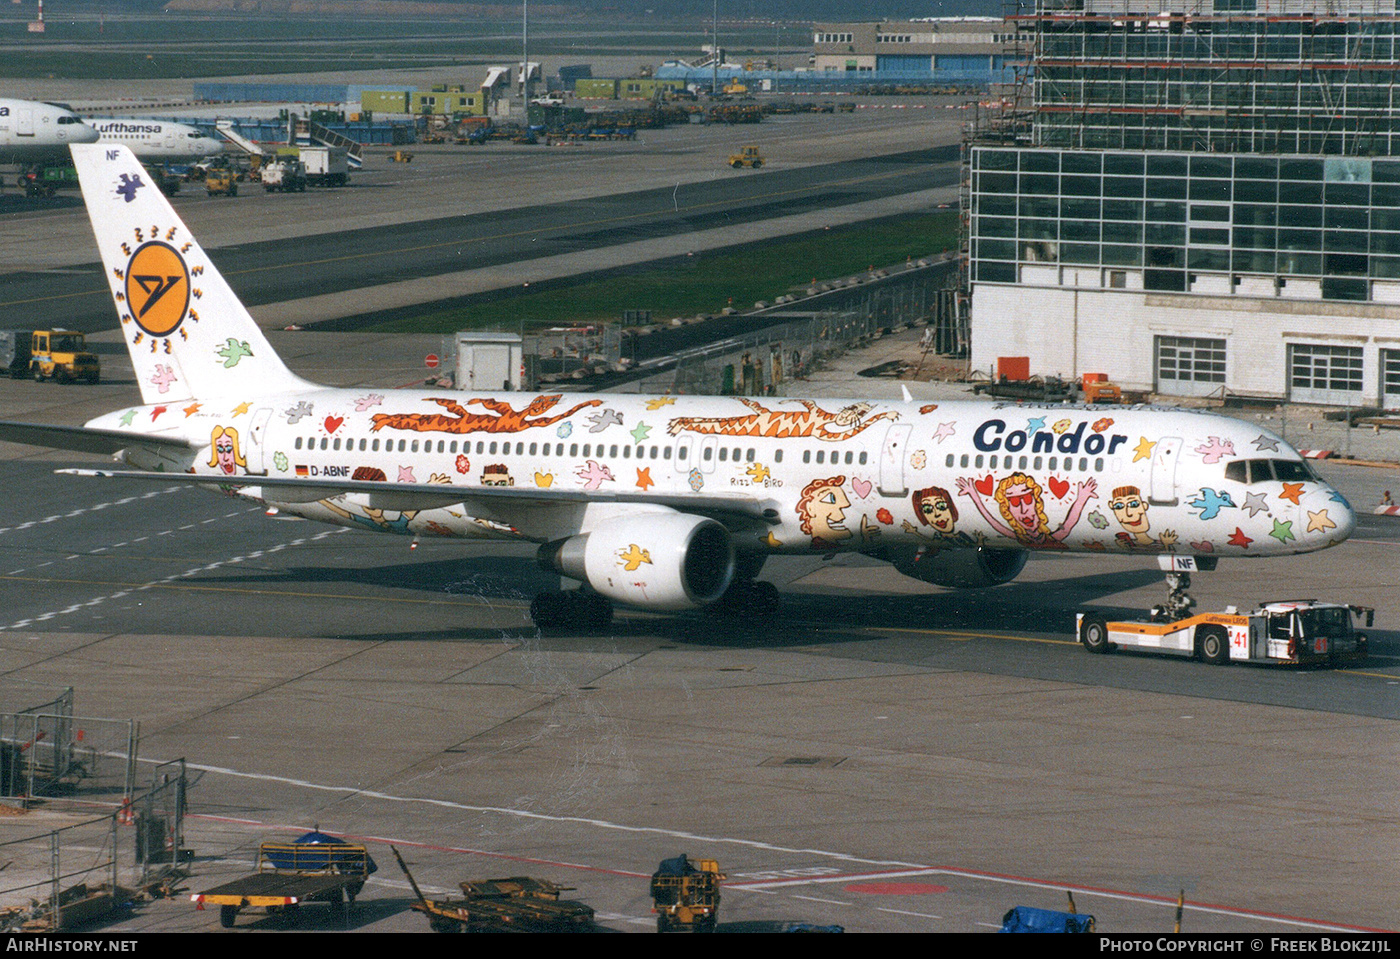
[0,146,1355,626]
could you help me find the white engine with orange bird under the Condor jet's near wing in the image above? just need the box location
[539,512,735,610]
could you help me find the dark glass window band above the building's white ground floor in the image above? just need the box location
[969,147,1400,300]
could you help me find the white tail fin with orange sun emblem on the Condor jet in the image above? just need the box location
[71,143,311,403]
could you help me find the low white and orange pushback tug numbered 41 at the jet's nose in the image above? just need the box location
[1075,599,1375,665]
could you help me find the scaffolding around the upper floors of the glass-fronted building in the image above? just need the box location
[1007,0,1400,157]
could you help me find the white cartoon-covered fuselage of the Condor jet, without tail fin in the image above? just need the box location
[90,389,1355,556]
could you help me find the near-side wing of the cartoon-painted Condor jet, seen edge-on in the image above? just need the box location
[56,464,778,524]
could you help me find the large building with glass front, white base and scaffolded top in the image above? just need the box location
[965,0,1400,406]
